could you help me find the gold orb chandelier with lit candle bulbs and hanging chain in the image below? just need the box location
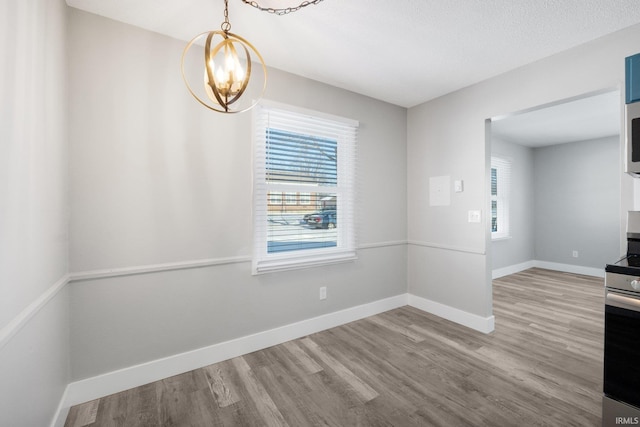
[181,0,323,113]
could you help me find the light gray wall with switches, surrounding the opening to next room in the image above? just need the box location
[407,25,640,316]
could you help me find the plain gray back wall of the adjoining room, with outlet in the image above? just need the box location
[533,136,620,268]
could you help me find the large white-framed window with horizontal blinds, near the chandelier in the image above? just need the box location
[253,101,358,274]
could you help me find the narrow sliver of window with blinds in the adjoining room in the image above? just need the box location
[491,157,511,239]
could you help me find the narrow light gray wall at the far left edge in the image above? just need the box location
[0,0,69,426]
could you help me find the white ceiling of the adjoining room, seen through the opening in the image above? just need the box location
[491,90,622,147]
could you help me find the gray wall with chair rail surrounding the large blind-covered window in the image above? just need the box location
[69,10,407,380]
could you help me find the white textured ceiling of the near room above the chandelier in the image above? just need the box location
[67,0,640,108]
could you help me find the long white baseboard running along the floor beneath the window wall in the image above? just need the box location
[53,294,408,427]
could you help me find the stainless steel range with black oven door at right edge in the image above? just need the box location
[602,211,640,427]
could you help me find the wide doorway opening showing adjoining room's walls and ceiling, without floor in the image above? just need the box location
[488,89,633,278]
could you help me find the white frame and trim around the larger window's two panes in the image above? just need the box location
[252,100,359,275]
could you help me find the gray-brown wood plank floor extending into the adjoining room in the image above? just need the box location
[65,269,604,427]
